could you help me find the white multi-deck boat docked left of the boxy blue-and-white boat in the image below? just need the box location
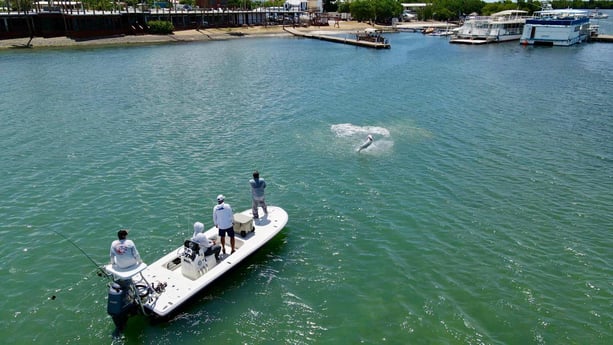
[449,10,528,44]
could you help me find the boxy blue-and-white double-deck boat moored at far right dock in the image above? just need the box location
[519,9,590,46]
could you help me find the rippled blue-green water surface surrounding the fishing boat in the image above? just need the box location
[0,13,613,345]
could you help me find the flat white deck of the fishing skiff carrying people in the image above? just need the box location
[134,206,288,316]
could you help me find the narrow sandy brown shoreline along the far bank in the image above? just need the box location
[0,21,446,50]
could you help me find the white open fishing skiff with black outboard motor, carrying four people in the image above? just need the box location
[104,206,288,331]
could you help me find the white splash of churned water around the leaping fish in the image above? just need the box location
[330,123,394,153]
